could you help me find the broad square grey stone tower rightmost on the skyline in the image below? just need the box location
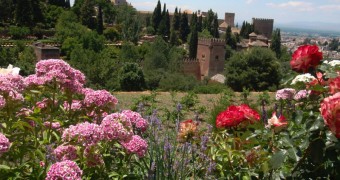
[253,18,274,39]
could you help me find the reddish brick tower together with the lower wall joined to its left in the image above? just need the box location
[182,39,225,80]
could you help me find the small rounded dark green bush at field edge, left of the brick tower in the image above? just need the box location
[119,63,145,91]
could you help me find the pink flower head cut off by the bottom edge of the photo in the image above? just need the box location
[46,160,83,180]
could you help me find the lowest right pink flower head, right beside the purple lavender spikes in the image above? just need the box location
[121,135,148,157]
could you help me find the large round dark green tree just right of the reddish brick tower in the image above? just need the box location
[225,48,282,91]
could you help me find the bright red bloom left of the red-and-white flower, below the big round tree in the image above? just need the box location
[216,104,260,128]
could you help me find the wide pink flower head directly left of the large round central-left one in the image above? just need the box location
[62,122,104,146]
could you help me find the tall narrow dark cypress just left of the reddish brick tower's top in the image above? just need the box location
[189,13,198,58]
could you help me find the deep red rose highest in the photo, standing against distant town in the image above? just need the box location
[290,45,322,73]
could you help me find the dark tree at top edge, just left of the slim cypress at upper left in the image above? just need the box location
[80,0,97,29]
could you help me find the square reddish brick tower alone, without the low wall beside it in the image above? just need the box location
[197,39,225,80]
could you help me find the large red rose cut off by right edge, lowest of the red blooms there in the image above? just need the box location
[320,92,340,138]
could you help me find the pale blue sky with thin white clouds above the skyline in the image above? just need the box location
[71,0,340,25]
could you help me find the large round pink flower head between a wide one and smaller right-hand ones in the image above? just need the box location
[100,113,133,141]
